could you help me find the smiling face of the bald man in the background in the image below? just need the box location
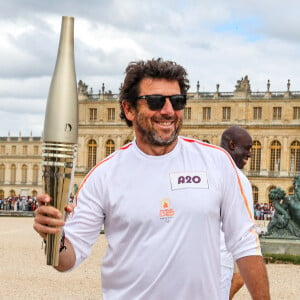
[230,134,252,169]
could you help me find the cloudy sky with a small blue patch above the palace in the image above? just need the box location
[0,0,300,136]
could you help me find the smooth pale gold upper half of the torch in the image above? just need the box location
[44,16,78,143]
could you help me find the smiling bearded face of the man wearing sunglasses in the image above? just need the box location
[123,78,182,155]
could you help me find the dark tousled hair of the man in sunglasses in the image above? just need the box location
[119,58,190,127]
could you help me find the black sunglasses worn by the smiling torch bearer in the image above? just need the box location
[137,95,186,110]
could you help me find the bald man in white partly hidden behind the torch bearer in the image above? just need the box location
[221,126,253,300]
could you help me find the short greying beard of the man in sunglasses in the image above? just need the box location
[136,114,182,146]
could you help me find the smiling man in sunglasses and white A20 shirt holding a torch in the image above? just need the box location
[33,59,270,300]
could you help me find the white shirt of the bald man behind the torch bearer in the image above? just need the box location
[220,167,254,269]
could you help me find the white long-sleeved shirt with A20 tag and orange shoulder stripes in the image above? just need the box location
[65,137,261,300]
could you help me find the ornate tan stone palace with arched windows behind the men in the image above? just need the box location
[0,76,300,203]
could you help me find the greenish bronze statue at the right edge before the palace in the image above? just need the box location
[265,176,300,238]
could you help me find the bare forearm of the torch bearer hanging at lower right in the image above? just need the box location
[237,255,270,300]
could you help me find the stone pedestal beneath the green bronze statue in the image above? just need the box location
[260,238,300,256]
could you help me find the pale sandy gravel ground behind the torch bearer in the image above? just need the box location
[0,217,300,300]
